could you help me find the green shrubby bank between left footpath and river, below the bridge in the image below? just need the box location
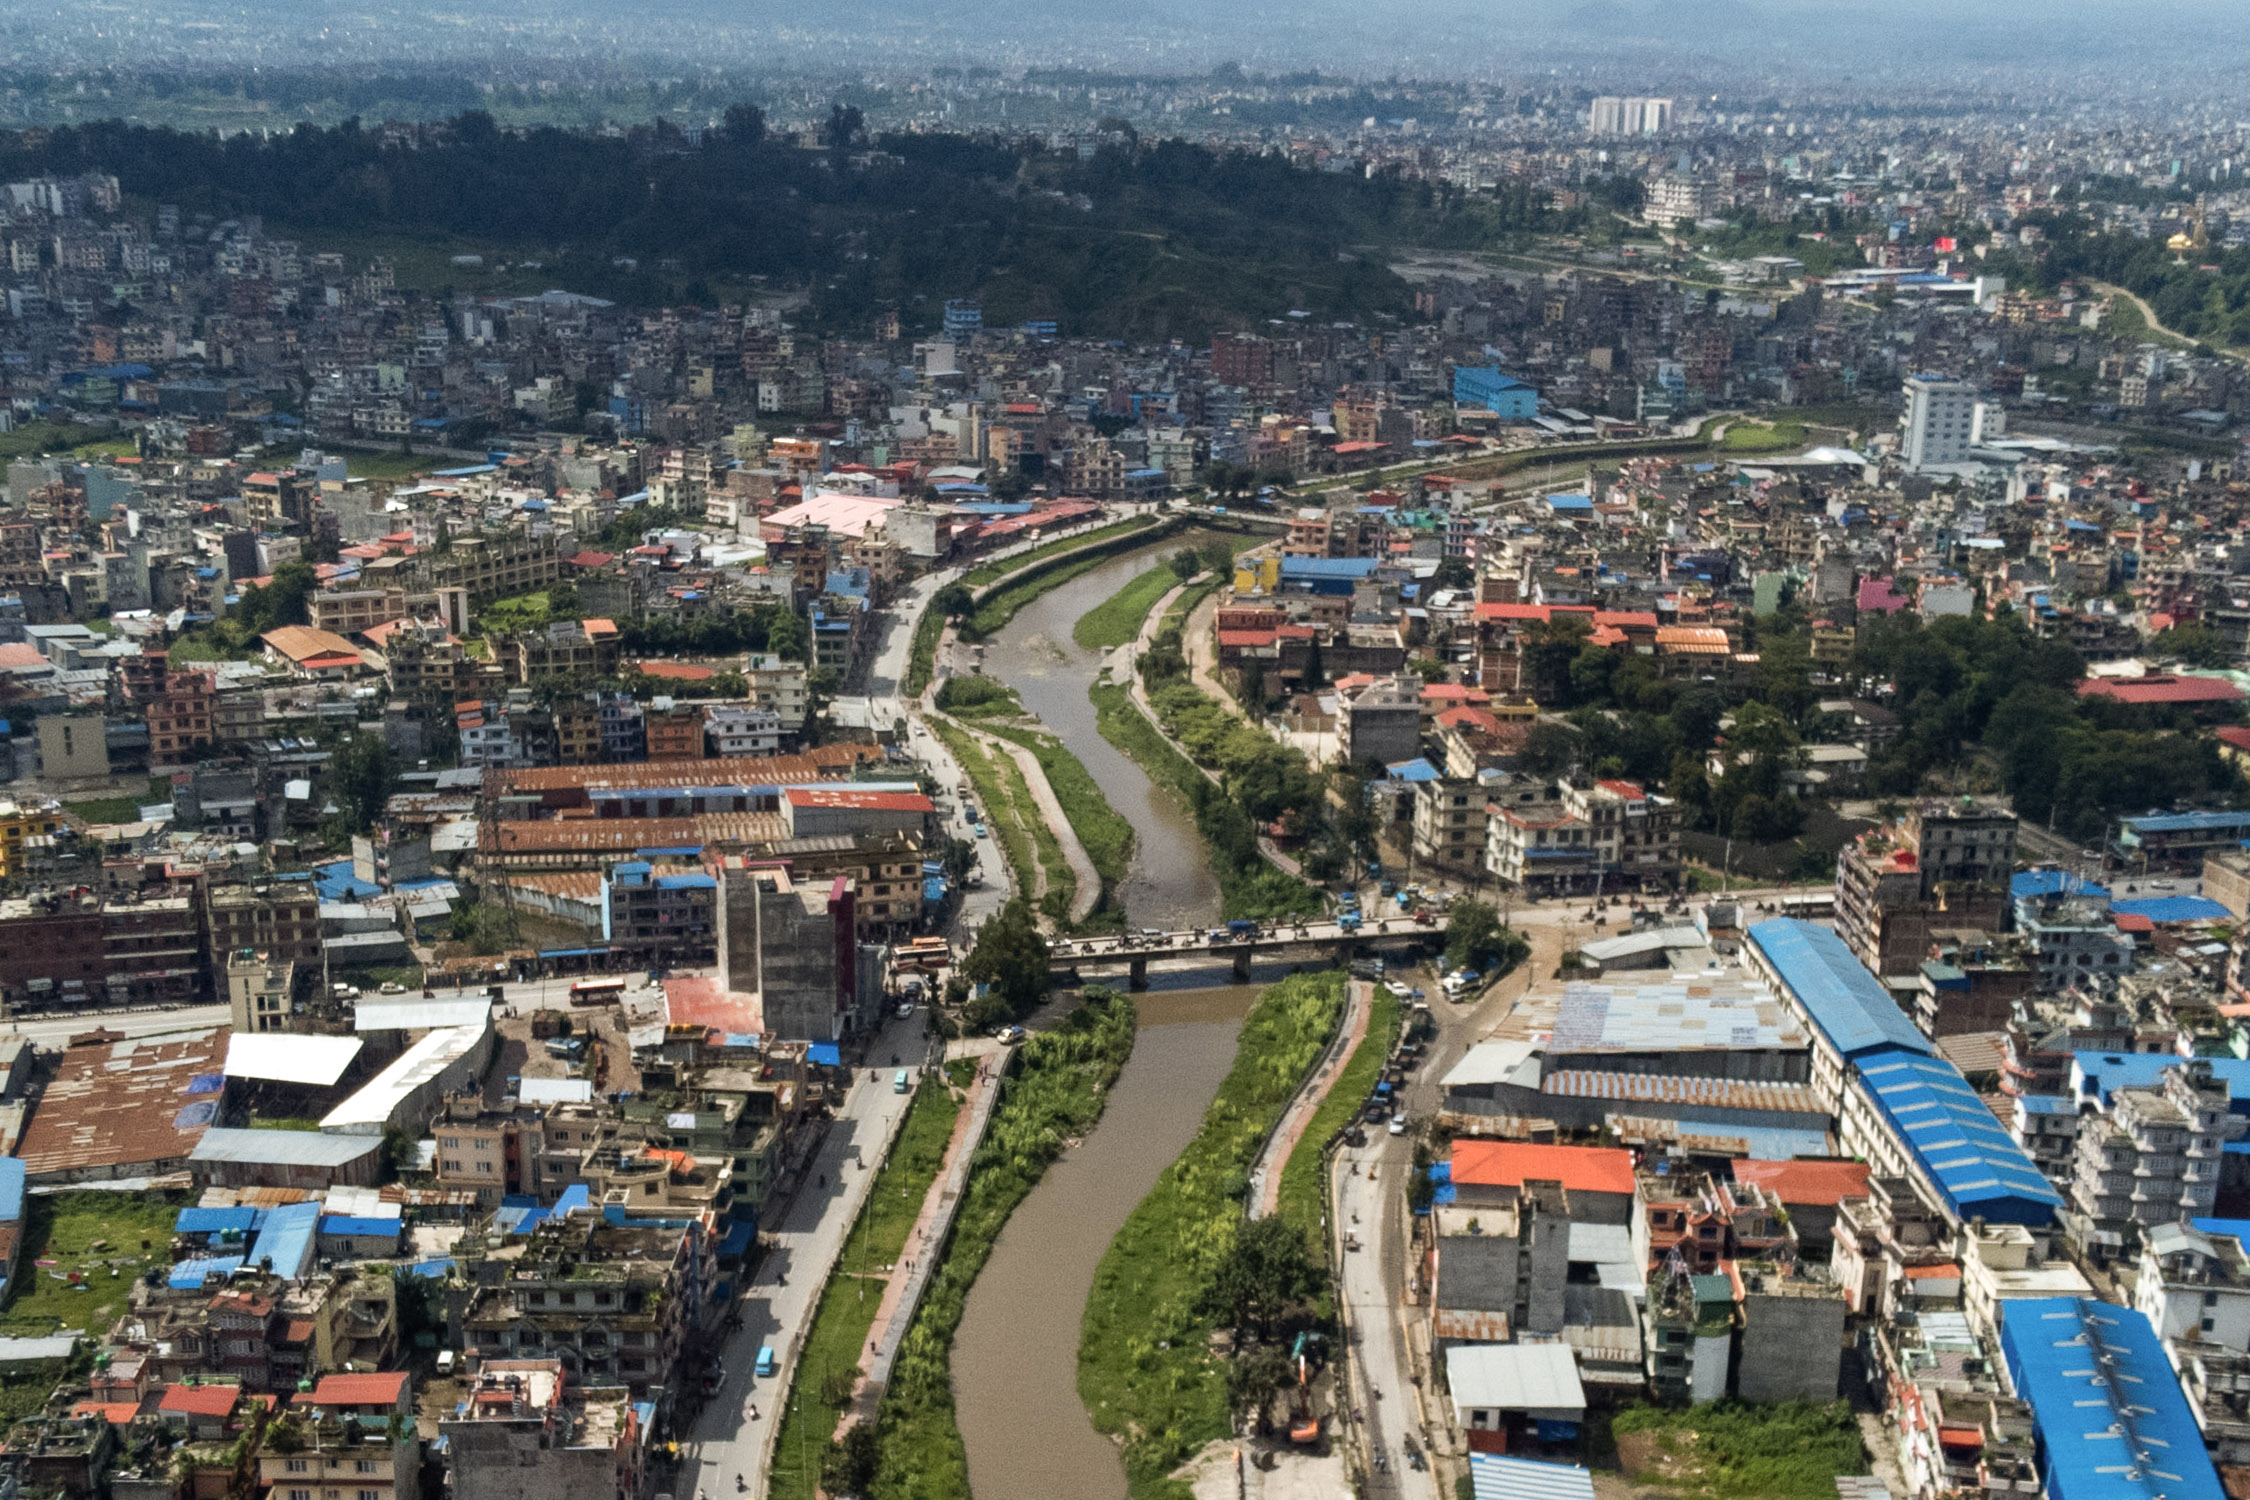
[869,990,1134,1500]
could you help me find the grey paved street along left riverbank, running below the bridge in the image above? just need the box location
[677,1019,927,1500]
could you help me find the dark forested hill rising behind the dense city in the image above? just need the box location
[0,106,1553,337]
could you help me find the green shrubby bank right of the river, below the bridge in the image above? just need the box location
[1078,972,1343,1500]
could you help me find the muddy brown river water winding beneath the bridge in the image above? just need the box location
[954,537,1258,1500]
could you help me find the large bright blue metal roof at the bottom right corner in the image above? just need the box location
[2000,1298,2225,1500]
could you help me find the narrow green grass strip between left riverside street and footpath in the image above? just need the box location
[767,1077,961,1500]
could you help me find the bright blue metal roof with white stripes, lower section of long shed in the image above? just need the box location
[1859,1052,2063,1228]
